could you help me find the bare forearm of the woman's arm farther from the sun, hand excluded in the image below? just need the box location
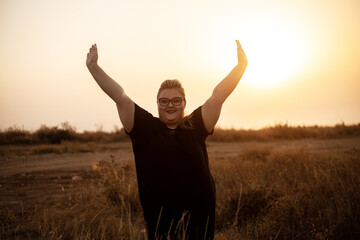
[88,64,125,103]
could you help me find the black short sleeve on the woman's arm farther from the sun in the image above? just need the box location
[126,104,154,139]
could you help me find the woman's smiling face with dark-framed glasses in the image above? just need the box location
[157,88,186,129]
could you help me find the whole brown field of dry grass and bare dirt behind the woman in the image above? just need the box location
[0,134,360,240]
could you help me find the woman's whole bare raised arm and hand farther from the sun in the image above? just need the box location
[86,44,135,132]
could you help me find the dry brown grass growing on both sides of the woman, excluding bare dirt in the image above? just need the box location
[0,142,360,240]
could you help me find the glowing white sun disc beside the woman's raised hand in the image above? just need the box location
[244,28,305,87]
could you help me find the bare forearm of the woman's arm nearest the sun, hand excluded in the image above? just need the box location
[213,64,246,103]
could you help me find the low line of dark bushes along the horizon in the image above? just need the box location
[0,122,360,145]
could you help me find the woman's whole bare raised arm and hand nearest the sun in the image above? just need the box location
[202,40,248,132]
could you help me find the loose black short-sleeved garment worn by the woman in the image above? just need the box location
[128,104,215,239]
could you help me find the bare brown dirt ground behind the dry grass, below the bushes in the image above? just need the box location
[0,137,360,216]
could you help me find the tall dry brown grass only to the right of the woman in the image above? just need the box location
[213,145,360,239]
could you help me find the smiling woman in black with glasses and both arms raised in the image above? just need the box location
[86,40,247,239]
